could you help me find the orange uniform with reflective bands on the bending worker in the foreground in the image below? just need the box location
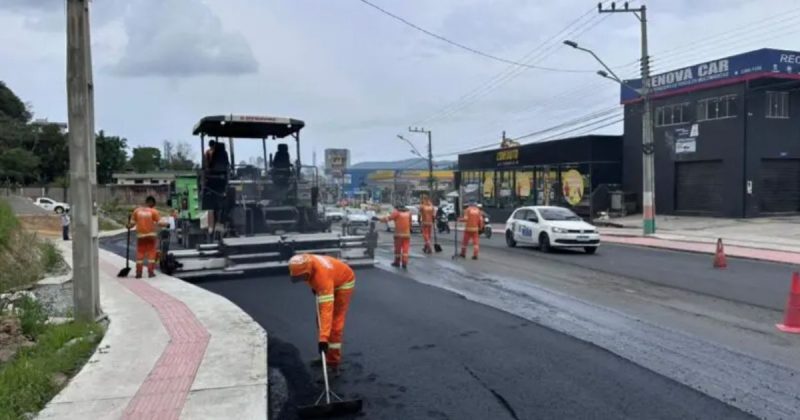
[308,255,356,342]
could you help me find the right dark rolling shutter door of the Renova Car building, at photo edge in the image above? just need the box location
[757,159,800,213]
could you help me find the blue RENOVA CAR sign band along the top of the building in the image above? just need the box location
[620,48,800,103]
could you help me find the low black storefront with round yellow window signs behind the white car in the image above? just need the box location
[456,136,622,222]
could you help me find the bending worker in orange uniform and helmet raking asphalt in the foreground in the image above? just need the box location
[289,254,356,373]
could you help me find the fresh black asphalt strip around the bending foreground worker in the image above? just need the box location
[103,235,747,419]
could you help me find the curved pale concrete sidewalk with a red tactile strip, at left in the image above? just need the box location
[38,242,267,420]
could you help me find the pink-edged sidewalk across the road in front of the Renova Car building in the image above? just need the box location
[482,215,800,265]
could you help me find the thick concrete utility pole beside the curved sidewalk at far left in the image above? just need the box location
[67,0,100,320]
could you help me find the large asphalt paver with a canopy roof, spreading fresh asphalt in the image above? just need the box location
[161,115,378,279]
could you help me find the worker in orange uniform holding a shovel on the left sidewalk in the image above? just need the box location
[128,196,168,279]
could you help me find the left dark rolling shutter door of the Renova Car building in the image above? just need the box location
[675,161,723,214]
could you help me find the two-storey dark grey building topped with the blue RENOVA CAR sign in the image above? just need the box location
[622,49,800,218]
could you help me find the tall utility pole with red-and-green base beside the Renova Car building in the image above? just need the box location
[597,2,656,235]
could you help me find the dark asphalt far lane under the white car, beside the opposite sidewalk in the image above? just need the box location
[434,233,797,311]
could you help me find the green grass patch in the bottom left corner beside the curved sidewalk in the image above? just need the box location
[0,316,103,420]
